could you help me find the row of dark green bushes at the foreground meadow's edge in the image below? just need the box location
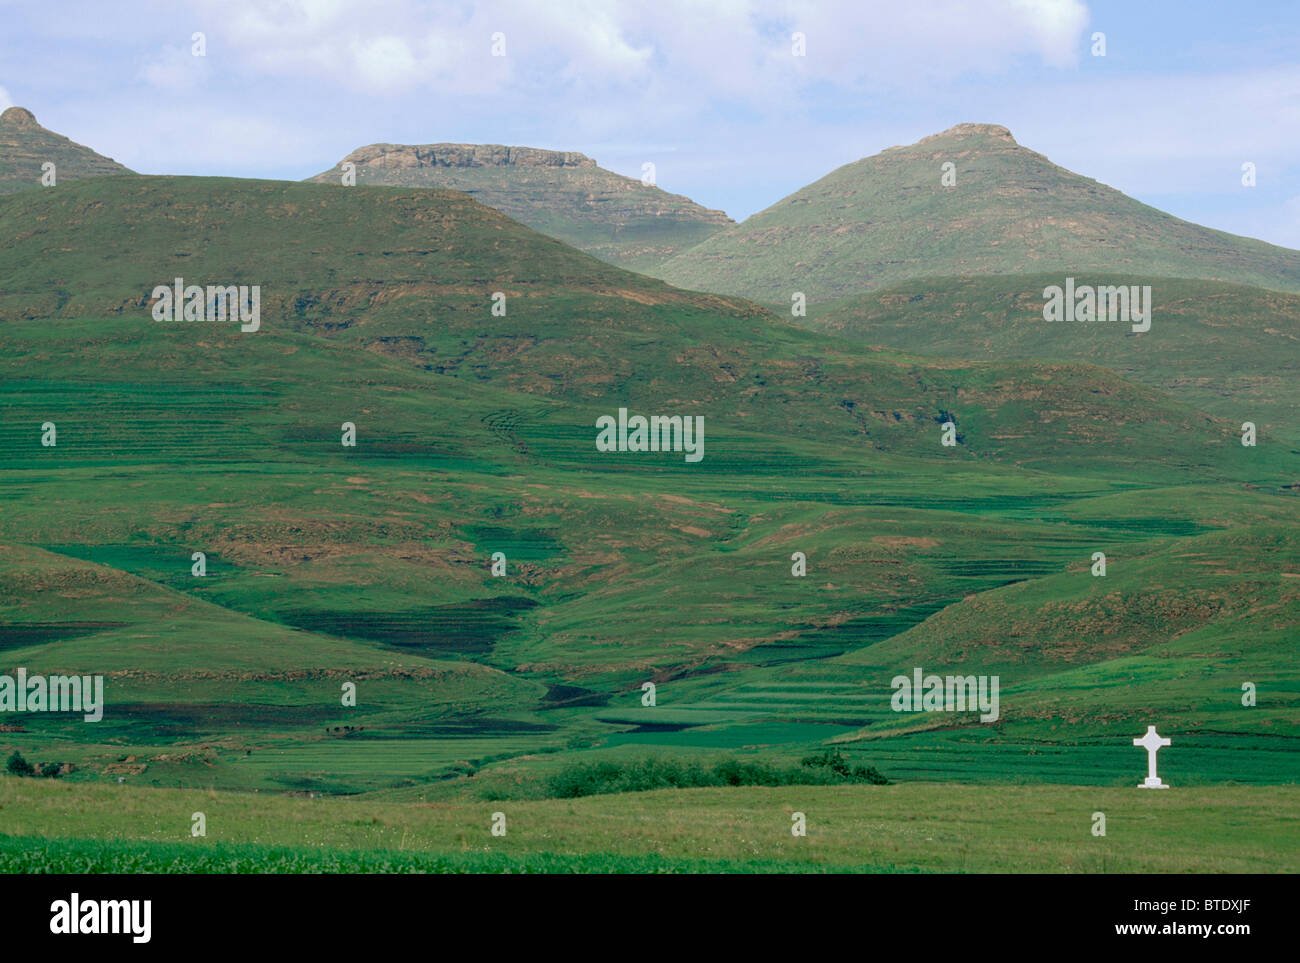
[547,750,889,799]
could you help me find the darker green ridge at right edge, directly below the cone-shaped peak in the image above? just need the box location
[798,274,1300,439]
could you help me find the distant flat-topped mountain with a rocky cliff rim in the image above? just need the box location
[311,144,733,270]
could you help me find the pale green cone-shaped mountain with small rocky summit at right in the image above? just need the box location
[653,123,1300,305]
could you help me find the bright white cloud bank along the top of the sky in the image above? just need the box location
[188,0,1088,107]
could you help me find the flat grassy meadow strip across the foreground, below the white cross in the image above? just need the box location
[0,778,1300,872]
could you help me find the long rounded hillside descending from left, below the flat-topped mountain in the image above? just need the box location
[0,177,1255,473]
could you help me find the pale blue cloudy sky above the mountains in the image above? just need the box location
[0,0,1300,248]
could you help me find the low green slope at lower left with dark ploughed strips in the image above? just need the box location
[0,543,545,789]
